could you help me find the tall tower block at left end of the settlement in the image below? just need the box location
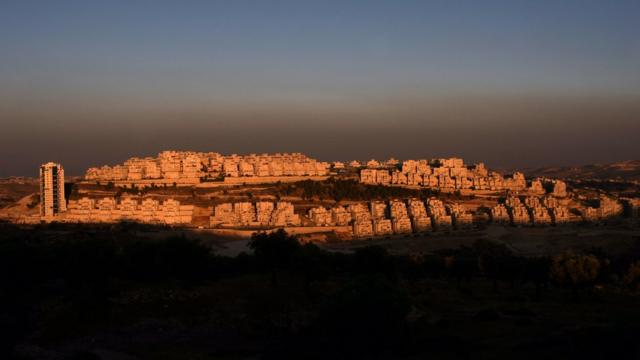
[40,162,67,217]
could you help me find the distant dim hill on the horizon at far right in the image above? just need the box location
[521,160,640,180]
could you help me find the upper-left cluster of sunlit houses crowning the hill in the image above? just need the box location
[84,151,330,185]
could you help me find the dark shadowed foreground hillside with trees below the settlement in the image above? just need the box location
[0,224,640,359]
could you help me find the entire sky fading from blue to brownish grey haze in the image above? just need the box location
[0,0,640,177]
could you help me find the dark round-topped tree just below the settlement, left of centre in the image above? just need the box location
[249,229,300,287]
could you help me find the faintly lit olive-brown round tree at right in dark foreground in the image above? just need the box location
[551,253,601,295]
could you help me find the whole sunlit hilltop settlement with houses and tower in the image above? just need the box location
[0,151,640,240]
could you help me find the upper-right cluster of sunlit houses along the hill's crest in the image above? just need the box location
[360,158,566,196]
